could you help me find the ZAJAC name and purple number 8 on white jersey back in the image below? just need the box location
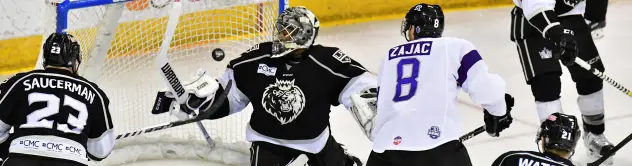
[389,41,432,102]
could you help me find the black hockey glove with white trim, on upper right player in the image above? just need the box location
[529,10,562,41]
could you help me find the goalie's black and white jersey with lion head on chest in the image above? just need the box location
[207,42,377,153]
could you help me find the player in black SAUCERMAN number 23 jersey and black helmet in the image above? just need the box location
[0,33,114,166]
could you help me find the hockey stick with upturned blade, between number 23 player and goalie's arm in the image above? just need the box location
[116,80,233,139]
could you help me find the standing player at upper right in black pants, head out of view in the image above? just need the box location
[510,0,614,165]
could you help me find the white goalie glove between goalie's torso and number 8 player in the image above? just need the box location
[351,88,377,140]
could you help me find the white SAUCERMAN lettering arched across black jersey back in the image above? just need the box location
[23,77,96,104]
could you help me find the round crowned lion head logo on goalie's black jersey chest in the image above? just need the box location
[261,79,305,125]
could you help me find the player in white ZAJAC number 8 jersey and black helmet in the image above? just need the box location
[358,3,513,166]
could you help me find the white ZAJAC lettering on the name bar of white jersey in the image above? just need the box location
[388,41,432,60]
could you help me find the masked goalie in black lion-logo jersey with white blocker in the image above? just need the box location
[160,7,377,166]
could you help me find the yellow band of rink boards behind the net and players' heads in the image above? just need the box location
[0,0,512,75]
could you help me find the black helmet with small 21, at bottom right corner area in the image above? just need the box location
[536,113,581,153]
